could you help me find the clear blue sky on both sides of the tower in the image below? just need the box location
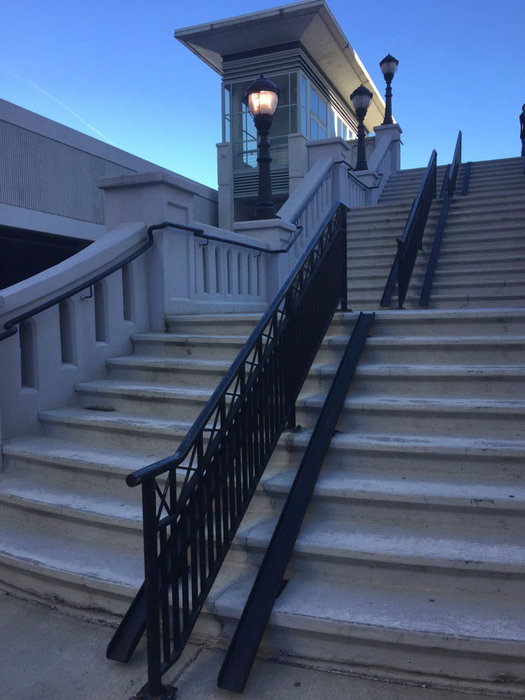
[0,0,525,186]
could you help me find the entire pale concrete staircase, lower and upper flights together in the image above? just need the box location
[0,154,525,697]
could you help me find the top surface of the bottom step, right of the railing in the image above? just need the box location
[215,576,525,654]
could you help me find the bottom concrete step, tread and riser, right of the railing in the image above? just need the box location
[214,574,525,690]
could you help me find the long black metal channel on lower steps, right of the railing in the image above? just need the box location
[218,313,374,692]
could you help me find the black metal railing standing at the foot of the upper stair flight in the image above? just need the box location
[380,150,437,309]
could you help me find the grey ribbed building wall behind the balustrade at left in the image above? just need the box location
[0,100,217,240]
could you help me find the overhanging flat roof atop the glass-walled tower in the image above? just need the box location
[175,0,385,131]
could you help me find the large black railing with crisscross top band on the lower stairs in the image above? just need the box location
[107,200,347,698]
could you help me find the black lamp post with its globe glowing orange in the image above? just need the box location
[243,75,280,219]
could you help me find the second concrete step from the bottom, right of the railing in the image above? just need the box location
[238,512,525,588]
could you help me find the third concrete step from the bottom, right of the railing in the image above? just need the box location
[263,459,525,532]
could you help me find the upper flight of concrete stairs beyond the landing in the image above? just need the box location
[348,158,525,309]
